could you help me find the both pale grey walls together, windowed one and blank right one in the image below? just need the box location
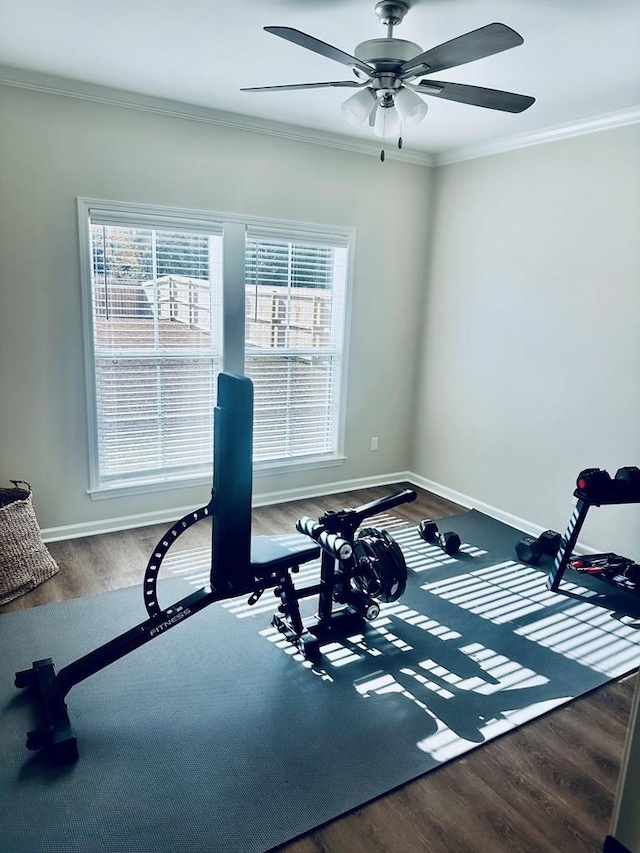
[0,80,640,557]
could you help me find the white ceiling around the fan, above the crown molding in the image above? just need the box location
[0,0,640,155]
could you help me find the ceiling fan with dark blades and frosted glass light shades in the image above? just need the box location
[241,0,535,147]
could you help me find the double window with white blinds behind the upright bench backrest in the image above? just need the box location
[80,200,349,497]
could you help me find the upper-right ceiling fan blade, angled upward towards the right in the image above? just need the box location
[400,24,524,78]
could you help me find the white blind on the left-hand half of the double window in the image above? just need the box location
[90,221,222,483]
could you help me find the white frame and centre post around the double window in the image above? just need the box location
[77,197,356,500]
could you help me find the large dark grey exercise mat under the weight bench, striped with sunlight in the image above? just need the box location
[0,511,640,853]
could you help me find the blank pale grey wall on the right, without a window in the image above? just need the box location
[413,125,640,559]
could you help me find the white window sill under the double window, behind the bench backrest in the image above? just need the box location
[87,455,346,501]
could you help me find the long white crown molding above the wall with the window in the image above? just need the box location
[0,65,435,166]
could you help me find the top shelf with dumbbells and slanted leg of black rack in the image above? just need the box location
[547,465,640,592]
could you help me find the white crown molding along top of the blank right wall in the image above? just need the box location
[433,107,640,166]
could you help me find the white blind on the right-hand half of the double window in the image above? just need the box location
[245,231,347,461]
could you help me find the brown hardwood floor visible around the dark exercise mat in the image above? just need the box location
[0,484,636,853]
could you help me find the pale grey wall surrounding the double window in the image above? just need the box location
[0,87,431,528]
